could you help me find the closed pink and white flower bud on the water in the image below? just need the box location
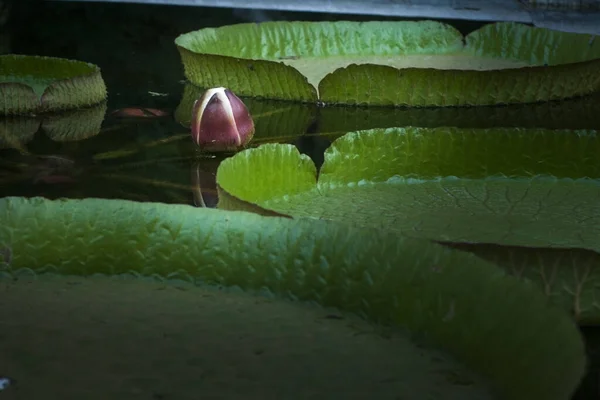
[192,87,254,151]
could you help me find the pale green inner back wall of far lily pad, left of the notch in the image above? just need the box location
[176,21,462,60]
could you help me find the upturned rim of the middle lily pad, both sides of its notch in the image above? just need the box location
[217,126,600,219]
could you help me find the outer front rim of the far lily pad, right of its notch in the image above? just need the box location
[319,60,600,107]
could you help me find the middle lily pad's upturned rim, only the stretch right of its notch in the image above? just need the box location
[320,127,600,180]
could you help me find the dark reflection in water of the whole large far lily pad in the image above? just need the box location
[175,82,600,145]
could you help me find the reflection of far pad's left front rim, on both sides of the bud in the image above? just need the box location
[175,83,317,146]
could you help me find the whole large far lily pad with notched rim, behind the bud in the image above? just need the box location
[175,21,600,106]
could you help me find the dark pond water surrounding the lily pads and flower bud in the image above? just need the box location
[0,3,600,399]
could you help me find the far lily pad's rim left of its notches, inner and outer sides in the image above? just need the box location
[175,21,462,102]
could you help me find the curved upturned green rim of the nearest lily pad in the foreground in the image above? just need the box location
[0,198,585,400]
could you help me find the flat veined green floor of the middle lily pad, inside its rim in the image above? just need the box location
[263,178,600,251]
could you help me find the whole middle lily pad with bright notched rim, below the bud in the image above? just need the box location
[217,128,600,322]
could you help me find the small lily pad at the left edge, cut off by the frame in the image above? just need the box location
[0,55,106,115]
